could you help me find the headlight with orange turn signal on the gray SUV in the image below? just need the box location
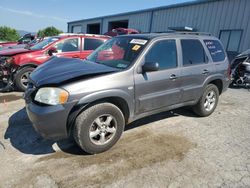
[35,87,69,105]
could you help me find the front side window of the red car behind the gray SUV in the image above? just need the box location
[55,38,79,53]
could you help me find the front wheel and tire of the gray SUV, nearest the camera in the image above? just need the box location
[73,103,125,154]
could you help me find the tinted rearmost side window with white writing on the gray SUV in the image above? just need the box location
[204,40,226,62]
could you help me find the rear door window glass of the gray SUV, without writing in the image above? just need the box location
[181,39,206,66]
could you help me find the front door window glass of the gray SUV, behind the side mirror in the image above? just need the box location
[145,40,177,70]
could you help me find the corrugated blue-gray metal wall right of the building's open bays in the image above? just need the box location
[152,0,250,51]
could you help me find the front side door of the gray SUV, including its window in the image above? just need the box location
[135,39,181,114]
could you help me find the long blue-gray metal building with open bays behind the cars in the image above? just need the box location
[68,0,250,54]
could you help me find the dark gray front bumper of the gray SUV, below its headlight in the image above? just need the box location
[26,102,76,140]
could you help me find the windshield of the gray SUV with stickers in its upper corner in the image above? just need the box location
[87,37,147,69]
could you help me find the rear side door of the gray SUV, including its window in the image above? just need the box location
[180,39,214,102]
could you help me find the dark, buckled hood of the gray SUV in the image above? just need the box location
[30,57,119,87]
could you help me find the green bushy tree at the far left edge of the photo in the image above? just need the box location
[0,26,20,41]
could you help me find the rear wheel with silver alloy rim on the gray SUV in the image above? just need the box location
[193,84,219,117]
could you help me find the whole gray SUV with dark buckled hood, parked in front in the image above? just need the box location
[25,33,230,154]
